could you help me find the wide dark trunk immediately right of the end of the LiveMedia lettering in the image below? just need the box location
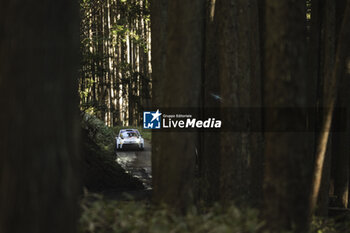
[216,0,262,202]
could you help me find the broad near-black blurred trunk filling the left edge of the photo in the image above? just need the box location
[0,0,80,233]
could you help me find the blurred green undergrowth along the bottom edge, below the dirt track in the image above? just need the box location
[79,192,263,233]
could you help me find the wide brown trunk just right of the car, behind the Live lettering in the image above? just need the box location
[152,0,204,209]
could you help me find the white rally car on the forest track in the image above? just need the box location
[115,129,144,150]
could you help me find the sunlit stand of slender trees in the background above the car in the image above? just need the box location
[79,0,152,126]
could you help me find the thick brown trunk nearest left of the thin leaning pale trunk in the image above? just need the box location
[264,0,314,232]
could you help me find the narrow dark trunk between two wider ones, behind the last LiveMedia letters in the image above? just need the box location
[197,0,220,203]
